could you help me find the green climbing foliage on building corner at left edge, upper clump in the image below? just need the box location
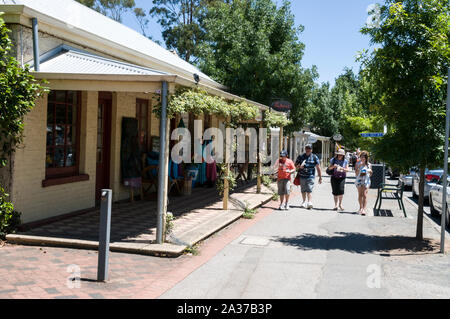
[0,17,44,167]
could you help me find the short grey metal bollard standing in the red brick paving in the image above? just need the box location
[97,189,112,281]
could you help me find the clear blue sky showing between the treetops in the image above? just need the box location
[123,0,377,85]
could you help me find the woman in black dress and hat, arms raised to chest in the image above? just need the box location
[328,149,348,211]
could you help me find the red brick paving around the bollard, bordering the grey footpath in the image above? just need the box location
[0,201,286,299]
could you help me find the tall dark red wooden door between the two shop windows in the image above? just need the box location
[95,94,112,201]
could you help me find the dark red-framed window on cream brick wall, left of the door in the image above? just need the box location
[45,91,81,179]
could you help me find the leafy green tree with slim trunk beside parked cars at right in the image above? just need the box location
[361,0,450,239]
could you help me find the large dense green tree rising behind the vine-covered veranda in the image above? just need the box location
[197,0,317,129]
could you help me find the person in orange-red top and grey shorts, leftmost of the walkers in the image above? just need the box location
[275,150,295,210]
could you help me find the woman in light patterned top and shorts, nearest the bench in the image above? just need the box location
[355,151,373,216]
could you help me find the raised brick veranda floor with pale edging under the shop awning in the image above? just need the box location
[6,181,276,256]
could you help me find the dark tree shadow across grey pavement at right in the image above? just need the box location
[274,232,439,254]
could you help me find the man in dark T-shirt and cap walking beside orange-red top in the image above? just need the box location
[295,144,322,209]
